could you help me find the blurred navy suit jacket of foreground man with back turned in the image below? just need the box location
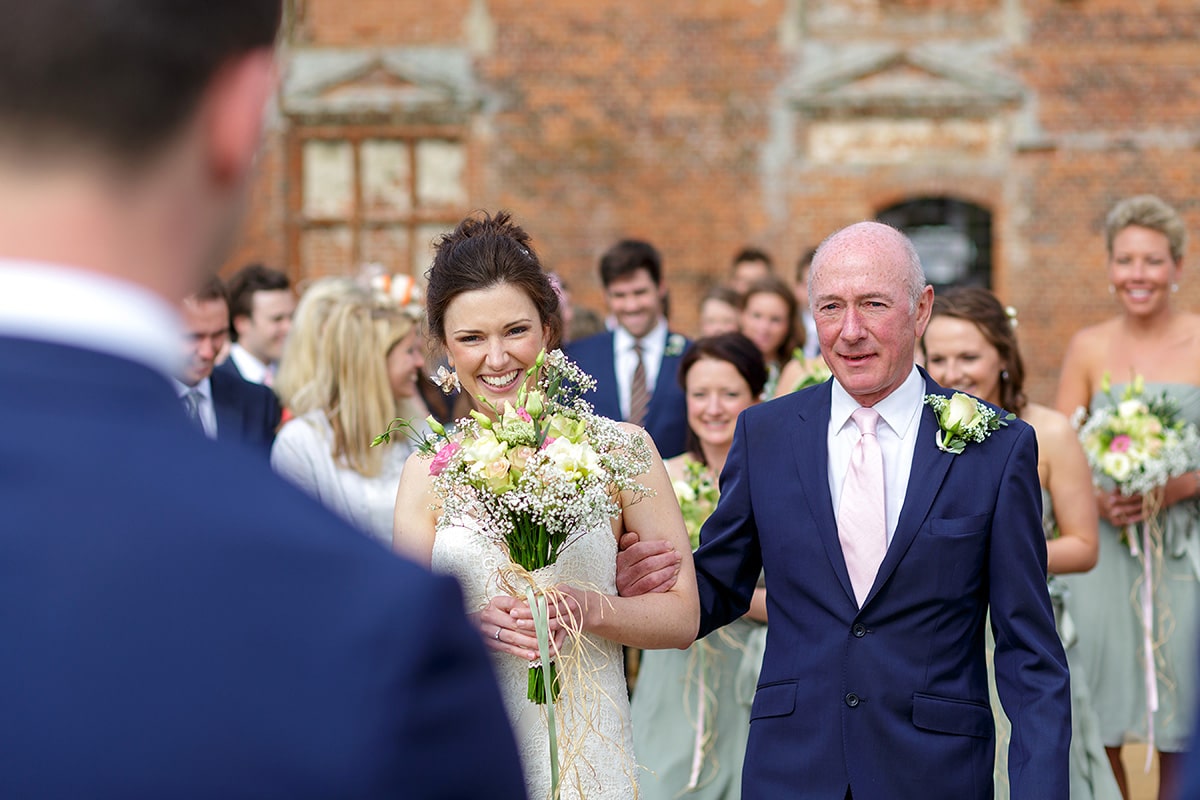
[0,337,526,800]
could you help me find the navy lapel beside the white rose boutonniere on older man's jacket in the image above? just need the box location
[863,369,955,604]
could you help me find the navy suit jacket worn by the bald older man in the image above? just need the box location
[696,373,1070,800]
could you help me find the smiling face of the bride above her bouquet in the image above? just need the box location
[445,283,550,413]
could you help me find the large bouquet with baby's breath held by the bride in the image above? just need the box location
[389,350,650,704]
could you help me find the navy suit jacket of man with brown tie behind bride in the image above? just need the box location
[566,331,688,458]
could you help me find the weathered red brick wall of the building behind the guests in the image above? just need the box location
[230,0,1200,401]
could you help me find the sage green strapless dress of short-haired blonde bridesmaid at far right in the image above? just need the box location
[1062,384,1200,752]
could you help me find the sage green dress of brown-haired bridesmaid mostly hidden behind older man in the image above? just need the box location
[988,489,1121,800]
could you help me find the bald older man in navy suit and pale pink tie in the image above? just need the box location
[618,222,1070,800]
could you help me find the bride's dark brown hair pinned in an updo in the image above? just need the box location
[425,211,563,350]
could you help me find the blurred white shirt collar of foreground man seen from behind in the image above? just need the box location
[0,259,185,377]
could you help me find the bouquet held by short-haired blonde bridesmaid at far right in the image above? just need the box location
[1079,374,1200,495]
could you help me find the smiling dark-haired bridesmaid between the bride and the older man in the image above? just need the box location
[632,333,767,800]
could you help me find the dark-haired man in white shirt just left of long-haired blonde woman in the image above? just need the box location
[221,264,296,386]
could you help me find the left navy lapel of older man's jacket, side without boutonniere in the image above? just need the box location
[792,381,857,602]
